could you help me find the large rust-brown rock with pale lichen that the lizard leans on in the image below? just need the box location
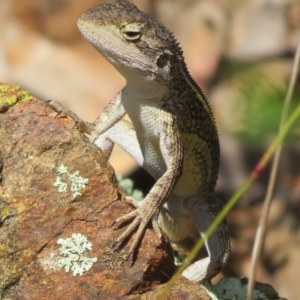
[0,85,173,300]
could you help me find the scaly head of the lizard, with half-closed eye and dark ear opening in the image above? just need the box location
[78,0,183,88]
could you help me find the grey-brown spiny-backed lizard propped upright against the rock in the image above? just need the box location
[50,0,230,282]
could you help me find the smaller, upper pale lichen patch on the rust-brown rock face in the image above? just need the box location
[53,165,89,197]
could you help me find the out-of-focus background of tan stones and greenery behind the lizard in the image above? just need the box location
[0,0,300,299]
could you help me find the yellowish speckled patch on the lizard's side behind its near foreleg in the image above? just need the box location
[174,133,212,196]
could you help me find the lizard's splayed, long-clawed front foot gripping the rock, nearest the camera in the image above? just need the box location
[113,203,162,257]
